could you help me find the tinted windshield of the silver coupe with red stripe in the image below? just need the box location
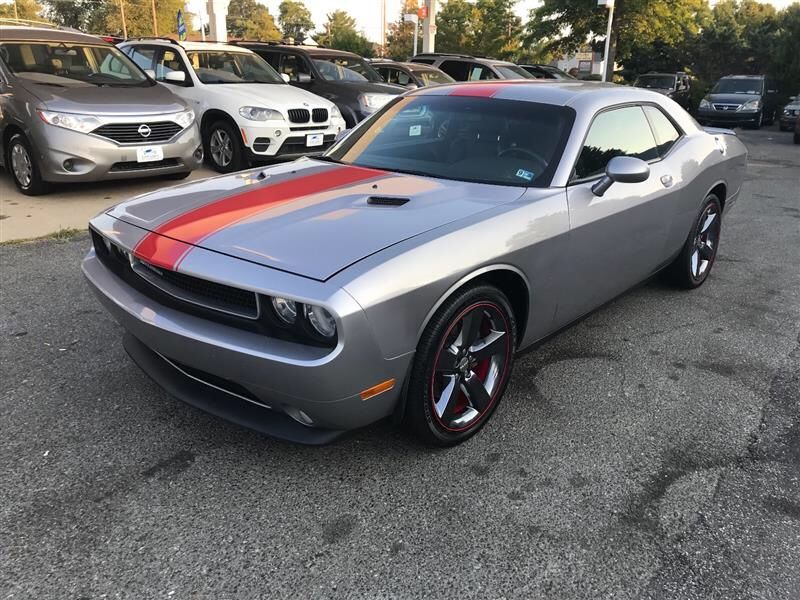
[326,94,575,187]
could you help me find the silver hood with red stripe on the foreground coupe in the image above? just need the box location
[108,159,525,281]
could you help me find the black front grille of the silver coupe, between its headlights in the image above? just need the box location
[132,258,259,319]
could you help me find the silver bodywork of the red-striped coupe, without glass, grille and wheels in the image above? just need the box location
[84,82,747,440]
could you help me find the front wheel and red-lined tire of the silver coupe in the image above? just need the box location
[406,285,517,446]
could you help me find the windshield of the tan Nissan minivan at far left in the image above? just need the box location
[0,42,150,87]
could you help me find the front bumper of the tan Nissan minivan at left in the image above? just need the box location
[31,122,203,182]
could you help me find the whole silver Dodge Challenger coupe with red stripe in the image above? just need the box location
[83,82,747,445]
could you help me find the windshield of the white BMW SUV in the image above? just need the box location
[186,50,285,84]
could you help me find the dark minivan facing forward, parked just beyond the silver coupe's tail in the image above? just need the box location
[697,75,779,129]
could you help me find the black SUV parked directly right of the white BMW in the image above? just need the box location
[237,42,406,128]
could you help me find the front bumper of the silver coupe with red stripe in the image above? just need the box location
[82,232,412,443]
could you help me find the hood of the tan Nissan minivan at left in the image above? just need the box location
[23,78,187,116]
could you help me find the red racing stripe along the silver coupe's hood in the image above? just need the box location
[133,166,384,271]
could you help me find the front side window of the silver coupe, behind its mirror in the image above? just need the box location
[574,106,659,179]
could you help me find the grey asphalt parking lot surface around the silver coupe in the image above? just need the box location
[0,131,800,600]
